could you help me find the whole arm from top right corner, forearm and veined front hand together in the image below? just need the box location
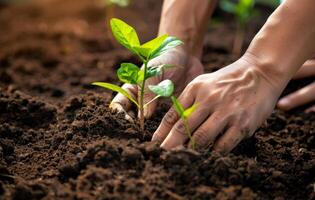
[153,0,315,152]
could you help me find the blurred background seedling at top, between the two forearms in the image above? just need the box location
[220,0,255,56]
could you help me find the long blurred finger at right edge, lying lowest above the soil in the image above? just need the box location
[277,82,315,110]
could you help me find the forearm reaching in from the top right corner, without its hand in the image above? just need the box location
[245,0,315,86]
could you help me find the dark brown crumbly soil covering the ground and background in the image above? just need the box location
[0,0,315,200]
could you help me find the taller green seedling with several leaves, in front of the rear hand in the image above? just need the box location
[92,18,182,130]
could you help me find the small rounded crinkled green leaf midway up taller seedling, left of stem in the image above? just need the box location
[117,63,140,84]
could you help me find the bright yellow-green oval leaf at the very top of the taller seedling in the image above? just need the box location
[110,18,140,54]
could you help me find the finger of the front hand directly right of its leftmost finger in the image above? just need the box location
[161,106,209,149]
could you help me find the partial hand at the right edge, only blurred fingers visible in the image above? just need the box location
[277,59,315,112]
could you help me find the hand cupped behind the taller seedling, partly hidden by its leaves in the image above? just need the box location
[110,49,203,120]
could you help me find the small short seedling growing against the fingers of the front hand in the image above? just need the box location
[171,96,198,149]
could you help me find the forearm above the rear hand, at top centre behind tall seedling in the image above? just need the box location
[159,0,216,58]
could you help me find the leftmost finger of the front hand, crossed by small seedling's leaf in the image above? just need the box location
[152,91,194,142]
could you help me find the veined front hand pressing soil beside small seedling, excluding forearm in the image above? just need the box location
[152,56,284,153]
